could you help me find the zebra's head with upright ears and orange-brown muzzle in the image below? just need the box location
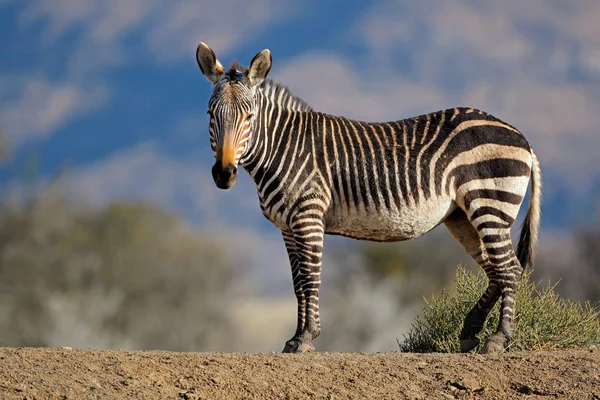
[196,43,272,189]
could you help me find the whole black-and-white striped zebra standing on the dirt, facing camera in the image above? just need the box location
[196,42,542,353]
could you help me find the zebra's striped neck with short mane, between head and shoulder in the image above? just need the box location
[241,79,312,177]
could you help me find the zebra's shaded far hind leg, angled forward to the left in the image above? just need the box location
[444,209,500,353]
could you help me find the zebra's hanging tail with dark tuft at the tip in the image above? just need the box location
[517,151,542,269]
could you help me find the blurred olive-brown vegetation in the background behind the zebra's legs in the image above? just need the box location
[0,131,600,351]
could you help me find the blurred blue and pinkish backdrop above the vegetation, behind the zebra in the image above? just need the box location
[0,0,600,236]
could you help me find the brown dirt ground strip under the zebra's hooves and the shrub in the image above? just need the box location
[0,347,600,400]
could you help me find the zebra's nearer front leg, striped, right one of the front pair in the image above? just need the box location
[283,218,324,353]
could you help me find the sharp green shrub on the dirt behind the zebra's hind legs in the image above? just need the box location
[398,266,600,353]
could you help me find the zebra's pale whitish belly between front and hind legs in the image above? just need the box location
[325,199,456,242]
